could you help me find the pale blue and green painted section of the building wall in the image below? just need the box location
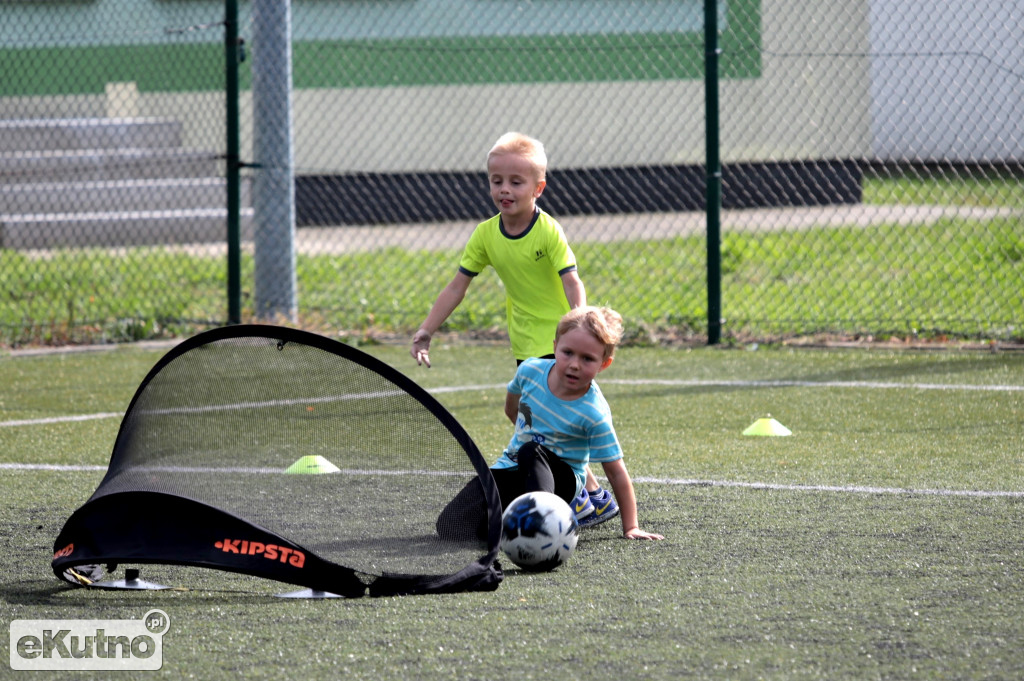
[0,0,761,96]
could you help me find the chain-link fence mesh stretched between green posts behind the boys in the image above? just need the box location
[0,0,1024,345]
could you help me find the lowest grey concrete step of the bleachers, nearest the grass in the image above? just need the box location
[0,208,253,250]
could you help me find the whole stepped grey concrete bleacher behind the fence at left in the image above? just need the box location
[0,118,252,250]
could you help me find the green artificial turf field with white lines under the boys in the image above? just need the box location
[0,343,1024,680]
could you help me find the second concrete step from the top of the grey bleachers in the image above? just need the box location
[0,148,224,184]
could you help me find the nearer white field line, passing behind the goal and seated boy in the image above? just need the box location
[0,463,1024,499]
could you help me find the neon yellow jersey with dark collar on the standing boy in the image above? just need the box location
[459,210,577,359]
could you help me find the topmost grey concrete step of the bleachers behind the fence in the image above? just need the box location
[0,118,182,152]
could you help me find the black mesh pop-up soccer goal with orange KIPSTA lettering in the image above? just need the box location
[52,325,502,597]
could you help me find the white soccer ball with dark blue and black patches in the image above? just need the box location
[499,492,580,572]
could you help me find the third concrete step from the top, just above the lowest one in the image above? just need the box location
[0,177,252,215]
